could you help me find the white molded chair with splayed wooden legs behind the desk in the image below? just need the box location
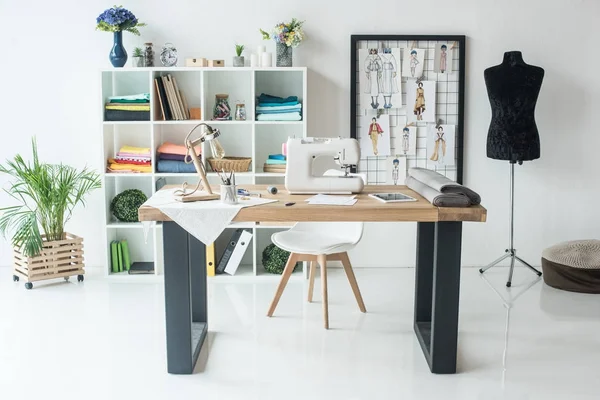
[267,222,367,329]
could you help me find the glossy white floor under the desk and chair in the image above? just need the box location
[0,268,600,400]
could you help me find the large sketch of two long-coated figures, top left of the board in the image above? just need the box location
[359,48,402,109]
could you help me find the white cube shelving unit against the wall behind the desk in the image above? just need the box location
[98,67,307,281]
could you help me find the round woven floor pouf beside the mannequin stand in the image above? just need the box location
[542,240,600,293]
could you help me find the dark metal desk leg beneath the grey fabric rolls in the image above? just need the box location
[414,222,462,374]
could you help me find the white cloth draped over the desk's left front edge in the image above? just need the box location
[143,189,277,244]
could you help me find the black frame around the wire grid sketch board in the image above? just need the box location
[350,34,466,184]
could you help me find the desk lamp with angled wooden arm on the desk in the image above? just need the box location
[175,122,225,202]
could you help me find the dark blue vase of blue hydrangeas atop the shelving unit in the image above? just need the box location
[96,6,146,67]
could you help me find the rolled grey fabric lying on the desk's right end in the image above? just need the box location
[405,168,481,207]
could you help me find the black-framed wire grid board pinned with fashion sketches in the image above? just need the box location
[349,34,466,184]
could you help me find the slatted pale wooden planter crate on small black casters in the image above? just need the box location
[13,232,85,289]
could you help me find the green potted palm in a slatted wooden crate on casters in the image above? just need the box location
[0,139,101,289]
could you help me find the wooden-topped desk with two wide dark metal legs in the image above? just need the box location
[138,185,487,374]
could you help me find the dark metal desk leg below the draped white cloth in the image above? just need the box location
[163,222,207,374]
